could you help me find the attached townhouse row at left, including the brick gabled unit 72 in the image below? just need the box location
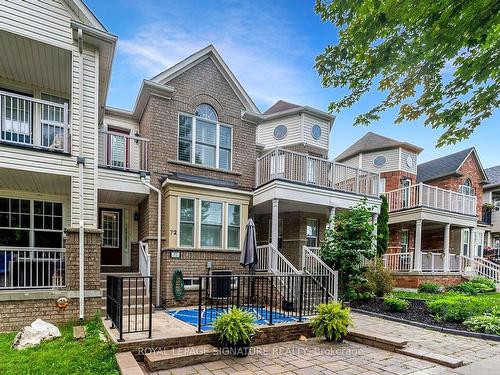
[0,0,380,330]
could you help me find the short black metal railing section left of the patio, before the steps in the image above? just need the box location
[106,276,153,341]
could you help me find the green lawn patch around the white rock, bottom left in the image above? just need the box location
[0,318,119,375]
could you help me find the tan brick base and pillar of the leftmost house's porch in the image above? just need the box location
[0,229,102,332]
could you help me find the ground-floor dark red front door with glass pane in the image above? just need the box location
[99,208,123,266]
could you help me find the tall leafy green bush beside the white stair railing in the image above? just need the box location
[321,199,375,298]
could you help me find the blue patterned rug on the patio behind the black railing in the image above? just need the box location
[166,306,299,331]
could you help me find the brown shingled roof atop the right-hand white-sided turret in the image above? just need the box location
[335,132,423,162]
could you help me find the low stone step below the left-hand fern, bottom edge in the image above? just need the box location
[144,345,222,371]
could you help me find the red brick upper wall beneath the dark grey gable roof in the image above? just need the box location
[426,154,483,217]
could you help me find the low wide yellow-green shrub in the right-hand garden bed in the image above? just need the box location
[427,295,496,323]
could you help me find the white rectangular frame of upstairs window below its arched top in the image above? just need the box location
[177,112,234,171]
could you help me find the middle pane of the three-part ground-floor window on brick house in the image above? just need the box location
[200,201,222,248]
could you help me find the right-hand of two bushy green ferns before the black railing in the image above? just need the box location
[310,302,352,342]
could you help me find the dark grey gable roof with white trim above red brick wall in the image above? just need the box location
[417,147,487,182]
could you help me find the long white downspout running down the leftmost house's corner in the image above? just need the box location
[77,28,85,320]
